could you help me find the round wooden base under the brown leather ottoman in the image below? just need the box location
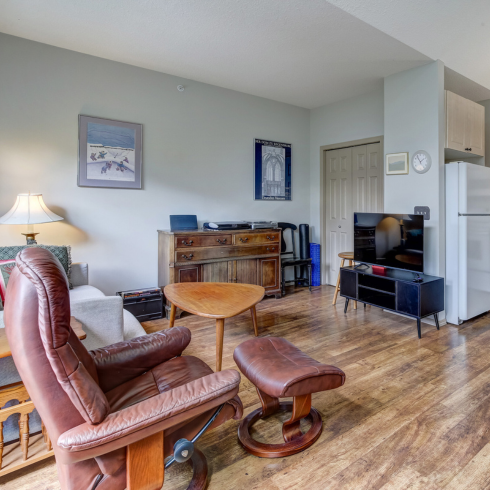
[238,389,323,458]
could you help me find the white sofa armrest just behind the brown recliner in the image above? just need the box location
[70,296,124,350]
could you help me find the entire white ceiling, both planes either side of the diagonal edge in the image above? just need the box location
[0,0,490,109]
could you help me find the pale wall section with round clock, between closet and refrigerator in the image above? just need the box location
[384,61,445,276]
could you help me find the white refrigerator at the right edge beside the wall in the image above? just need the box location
[445,162,490,325]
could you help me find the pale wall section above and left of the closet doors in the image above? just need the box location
[310,90,384,243]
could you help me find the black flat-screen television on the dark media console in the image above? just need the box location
[354,213,424,273]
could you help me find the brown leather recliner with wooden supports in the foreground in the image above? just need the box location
[5,248,242,490]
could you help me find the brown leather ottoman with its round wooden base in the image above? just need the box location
[233,337,345,458]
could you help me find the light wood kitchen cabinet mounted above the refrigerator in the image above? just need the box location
[446,90,485,157]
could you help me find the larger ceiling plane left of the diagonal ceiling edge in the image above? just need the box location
[0,0,431,108]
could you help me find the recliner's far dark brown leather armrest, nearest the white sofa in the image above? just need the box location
[90,327,191,393]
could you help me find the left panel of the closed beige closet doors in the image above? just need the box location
[325,148,354,284]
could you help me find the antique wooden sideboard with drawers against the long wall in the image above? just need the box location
[158,228,281,318]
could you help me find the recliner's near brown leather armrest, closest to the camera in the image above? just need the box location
[56,369,240,463]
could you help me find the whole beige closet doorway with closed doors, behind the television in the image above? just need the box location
[322,138,384,286]
